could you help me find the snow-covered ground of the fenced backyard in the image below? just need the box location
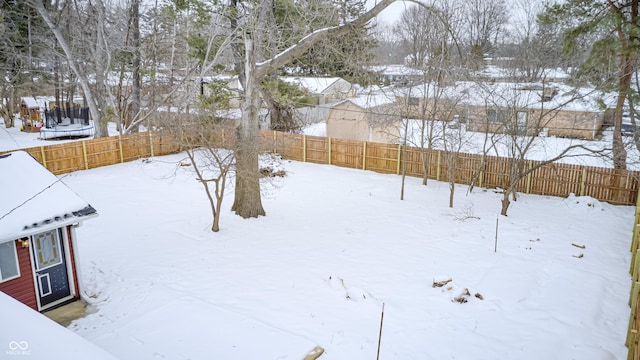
[43,154,634,360]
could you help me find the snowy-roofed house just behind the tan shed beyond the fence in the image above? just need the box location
[280,76,356,105]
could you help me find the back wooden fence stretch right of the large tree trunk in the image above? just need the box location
[262,131,640,205]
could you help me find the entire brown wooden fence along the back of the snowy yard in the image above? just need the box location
[2,130,640,205]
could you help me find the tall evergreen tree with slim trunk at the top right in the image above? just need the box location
[541,0,640,169]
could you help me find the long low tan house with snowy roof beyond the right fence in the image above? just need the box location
[400,82,604,140]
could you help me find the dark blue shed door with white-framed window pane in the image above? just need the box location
[32,229,71,309]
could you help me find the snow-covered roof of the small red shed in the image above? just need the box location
[0,151,97,243]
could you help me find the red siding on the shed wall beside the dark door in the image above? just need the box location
[0,241,38,311]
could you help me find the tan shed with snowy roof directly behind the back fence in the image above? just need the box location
[327,94,401,143]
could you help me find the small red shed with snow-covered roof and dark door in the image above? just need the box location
[0,151,97,311]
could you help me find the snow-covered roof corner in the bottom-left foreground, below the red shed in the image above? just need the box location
[0,292,116,360]
